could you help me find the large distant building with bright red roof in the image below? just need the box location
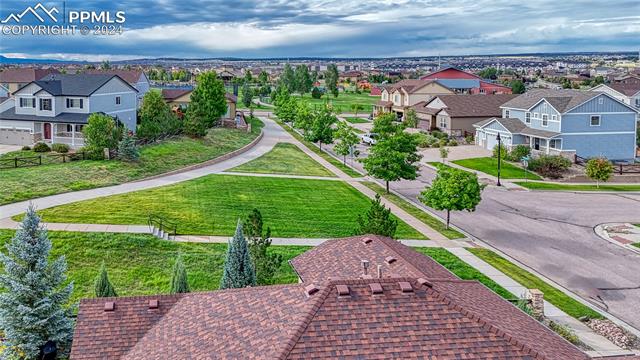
[420,66,511,94]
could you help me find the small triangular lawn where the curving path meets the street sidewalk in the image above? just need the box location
[229,143,335,177]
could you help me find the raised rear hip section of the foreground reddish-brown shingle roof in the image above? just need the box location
[290,235,456,283]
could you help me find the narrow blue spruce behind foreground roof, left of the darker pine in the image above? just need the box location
[220,219,256,289]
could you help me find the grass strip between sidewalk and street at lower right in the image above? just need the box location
[467,248,602,319]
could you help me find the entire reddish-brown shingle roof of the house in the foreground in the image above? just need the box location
[70,236,589,360]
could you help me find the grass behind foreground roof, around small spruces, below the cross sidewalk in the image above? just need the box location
[0,230,309,301]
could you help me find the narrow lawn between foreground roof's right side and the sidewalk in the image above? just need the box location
[413,248,517,300]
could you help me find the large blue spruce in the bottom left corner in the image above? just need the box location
[0,206,73,359]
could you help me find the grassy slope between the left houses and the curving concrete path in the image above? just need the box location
[0,119,263,205]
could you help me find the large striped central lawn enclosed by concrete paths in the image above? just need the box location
[33,175,425,239]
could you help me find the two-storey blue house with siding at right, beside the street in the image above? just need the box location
[474,89,638,161]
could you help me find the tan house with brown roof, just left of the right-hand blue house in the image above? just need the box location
[413,94,518,136]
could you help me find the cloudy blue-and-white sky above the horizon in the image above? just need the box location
[0,0,640,61]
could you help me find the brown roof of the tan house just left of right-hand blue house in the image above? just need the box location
[425,94,518,117]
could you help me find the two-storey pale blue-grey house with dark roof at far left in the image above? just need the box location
[0,74,138,147]
